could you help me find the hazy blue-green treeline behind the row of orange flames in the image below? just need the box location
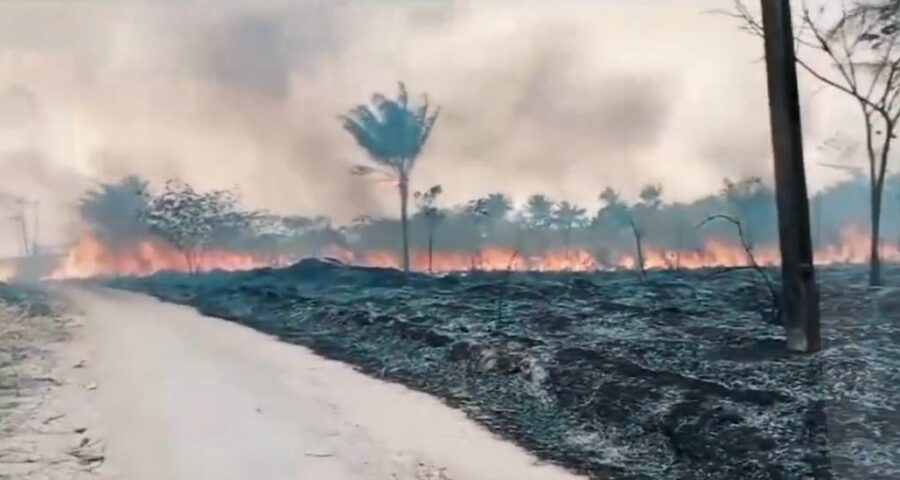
[79,172,900,270]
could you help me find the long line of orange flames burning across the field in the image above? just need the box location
[42,226,900,280]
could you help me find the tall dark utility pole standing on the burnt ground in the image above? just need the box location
[761,0,822,352]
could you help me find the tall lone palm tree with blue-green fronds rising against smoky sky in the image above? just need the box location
[339,82,440,271]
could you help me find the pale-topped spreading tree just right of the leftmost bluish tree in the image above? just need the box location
[142,180,253,274]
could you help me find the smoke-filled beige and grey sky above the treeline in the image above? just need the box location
[0,0,872,256]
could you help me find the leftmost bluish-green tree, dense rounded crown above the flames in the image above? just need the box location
[78,176,150,249]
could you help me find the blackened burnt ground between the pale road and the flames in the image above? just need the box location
[110,261,900,480]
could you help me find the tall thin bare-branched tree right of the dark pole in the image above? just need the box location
[729,0,900,286]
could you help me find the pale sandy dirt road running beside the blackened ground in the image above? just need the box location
[59,289,580,480]
